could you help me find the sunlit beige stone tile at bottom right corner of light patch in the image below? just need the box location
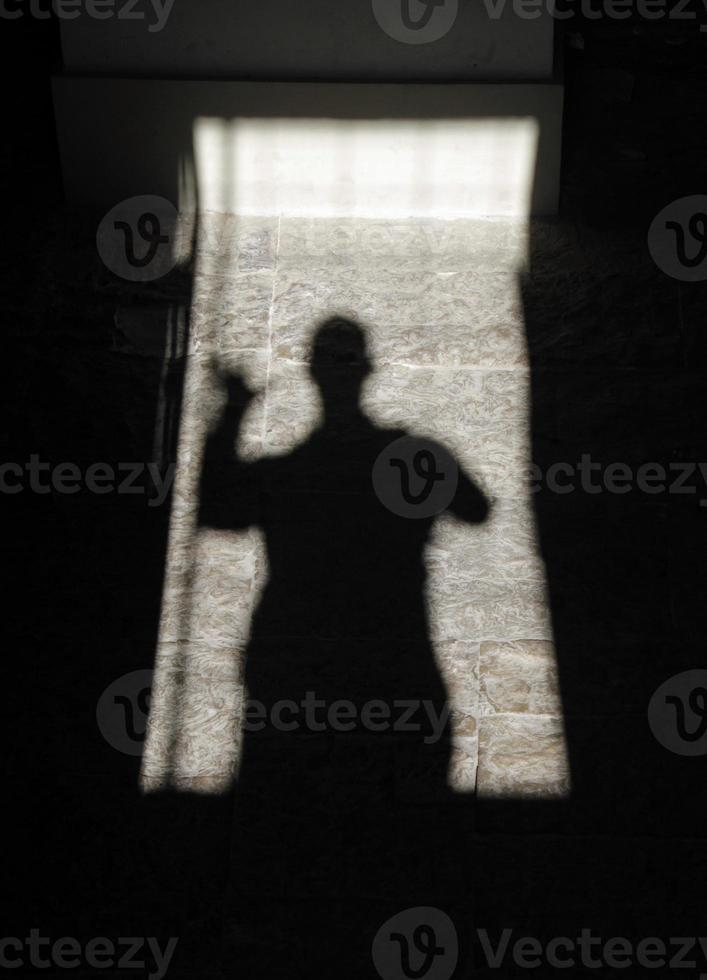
[478,715,569,798]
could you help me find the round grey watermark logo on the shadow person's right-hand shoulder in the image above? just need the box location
[372,436,458,519]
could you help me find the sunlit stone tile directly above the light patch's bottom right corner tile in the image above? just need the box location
[479,640,562,715]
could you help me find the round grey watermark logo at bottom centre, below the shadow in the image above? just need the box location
[371,906,459,980]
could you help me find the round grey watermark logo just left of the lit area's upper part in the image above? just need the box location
[96,194,178,282]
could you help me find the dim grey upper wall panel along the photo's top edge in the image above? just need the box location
[56,0,553,81]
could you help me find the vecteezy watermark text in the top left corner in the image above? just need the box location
[0,0,174,34]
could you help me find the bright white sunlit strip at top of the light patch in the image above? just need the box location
[194,118,538,218]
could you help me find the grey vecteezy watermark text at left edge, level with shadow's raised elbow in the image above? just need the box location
[0,453,175,507]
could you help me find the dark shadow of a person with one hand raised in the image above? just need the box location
[200,319,488,980]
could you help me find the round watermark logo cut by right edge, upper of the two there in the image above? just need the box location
[648,194,707,282]
